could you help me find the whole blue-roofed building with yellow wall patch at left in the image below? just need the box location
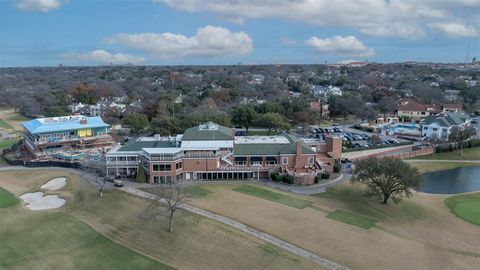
[22,115,112,156]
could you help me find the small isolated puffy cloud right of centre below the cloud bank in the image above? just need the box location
[305,36,375,57]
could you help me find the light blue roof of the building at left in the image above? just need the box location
[22,115,110,134]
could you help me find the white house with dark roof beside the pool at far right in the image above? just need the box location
[420,112,469,141]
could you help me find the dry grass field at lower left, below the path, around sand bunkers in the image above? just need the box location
[0,170,319,269]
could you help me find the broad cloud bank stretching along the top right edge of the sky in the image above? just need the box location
[154,0,480,39]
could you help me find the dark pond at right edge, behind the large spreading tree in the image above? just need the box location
[419,167,480,194]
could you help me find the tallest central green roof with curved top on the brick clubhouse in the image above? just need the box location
[182,122,233,141]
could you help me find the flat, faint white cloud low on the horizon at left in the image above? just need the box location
[61,50,145,65]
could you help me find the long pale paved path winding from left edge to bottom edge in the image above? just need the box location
[0,166,350,270]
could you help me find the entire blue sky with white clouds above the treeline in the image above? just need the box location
[0,0,480,67]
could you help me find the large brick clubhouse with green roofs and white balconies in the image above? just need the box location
[106,122,342,184]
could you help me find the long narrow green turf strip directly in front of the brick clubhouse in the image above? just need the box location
[233,185,312,209]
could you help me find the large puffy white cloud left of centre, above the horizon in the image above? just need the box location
[105,25,253,59]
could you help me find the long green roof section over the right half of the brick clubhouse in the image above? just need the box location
[233,143,315,156]
